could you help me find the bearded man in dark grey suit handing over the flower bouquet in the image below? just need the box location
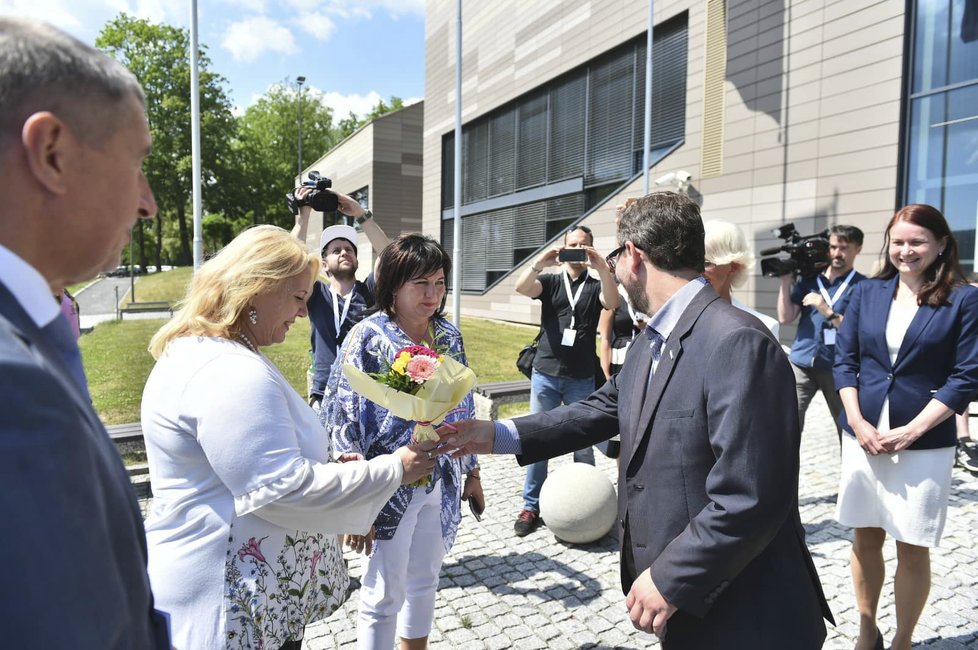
[439,192,832,650]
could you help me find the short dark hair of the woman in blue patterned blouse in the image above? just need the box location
[373,233,452,317]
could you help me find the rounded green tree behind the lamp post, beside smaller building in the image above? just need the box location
[234,79,341,228]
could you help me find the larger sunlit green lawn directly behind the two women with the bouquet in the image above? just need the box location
[80,310,534,424]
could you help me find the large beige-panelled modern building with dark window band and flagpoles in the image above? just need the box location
[423,0,978,340]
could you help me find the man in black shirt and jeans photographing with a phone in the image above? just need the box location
[513,226,618,537]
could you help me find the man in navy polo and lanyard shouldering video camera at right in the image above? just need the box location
[778,226,865,442]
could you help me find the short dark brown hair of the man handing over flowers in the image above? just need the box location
[618,192,706,273]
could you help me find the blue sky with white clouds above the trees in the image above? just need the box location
[0,0,424,119]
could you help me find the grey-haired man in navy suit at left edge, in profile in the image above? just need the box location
[0,17,170,650]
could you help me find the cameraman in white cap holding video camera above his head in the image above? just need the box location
[286,180,390,411]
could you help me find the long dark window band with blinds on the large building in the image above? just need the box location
[441,13,688,291]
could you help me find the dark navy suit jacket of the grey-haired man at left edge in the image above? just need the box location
[0,283,170,650]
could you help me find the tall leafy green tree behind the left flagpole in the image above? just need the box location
[95,13,237,266]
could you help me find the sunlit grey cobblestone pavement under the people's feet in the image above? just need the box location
[303,395,978,650]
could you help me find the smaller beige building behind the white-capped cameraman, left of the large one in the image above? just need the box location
[303,102,424,268]
